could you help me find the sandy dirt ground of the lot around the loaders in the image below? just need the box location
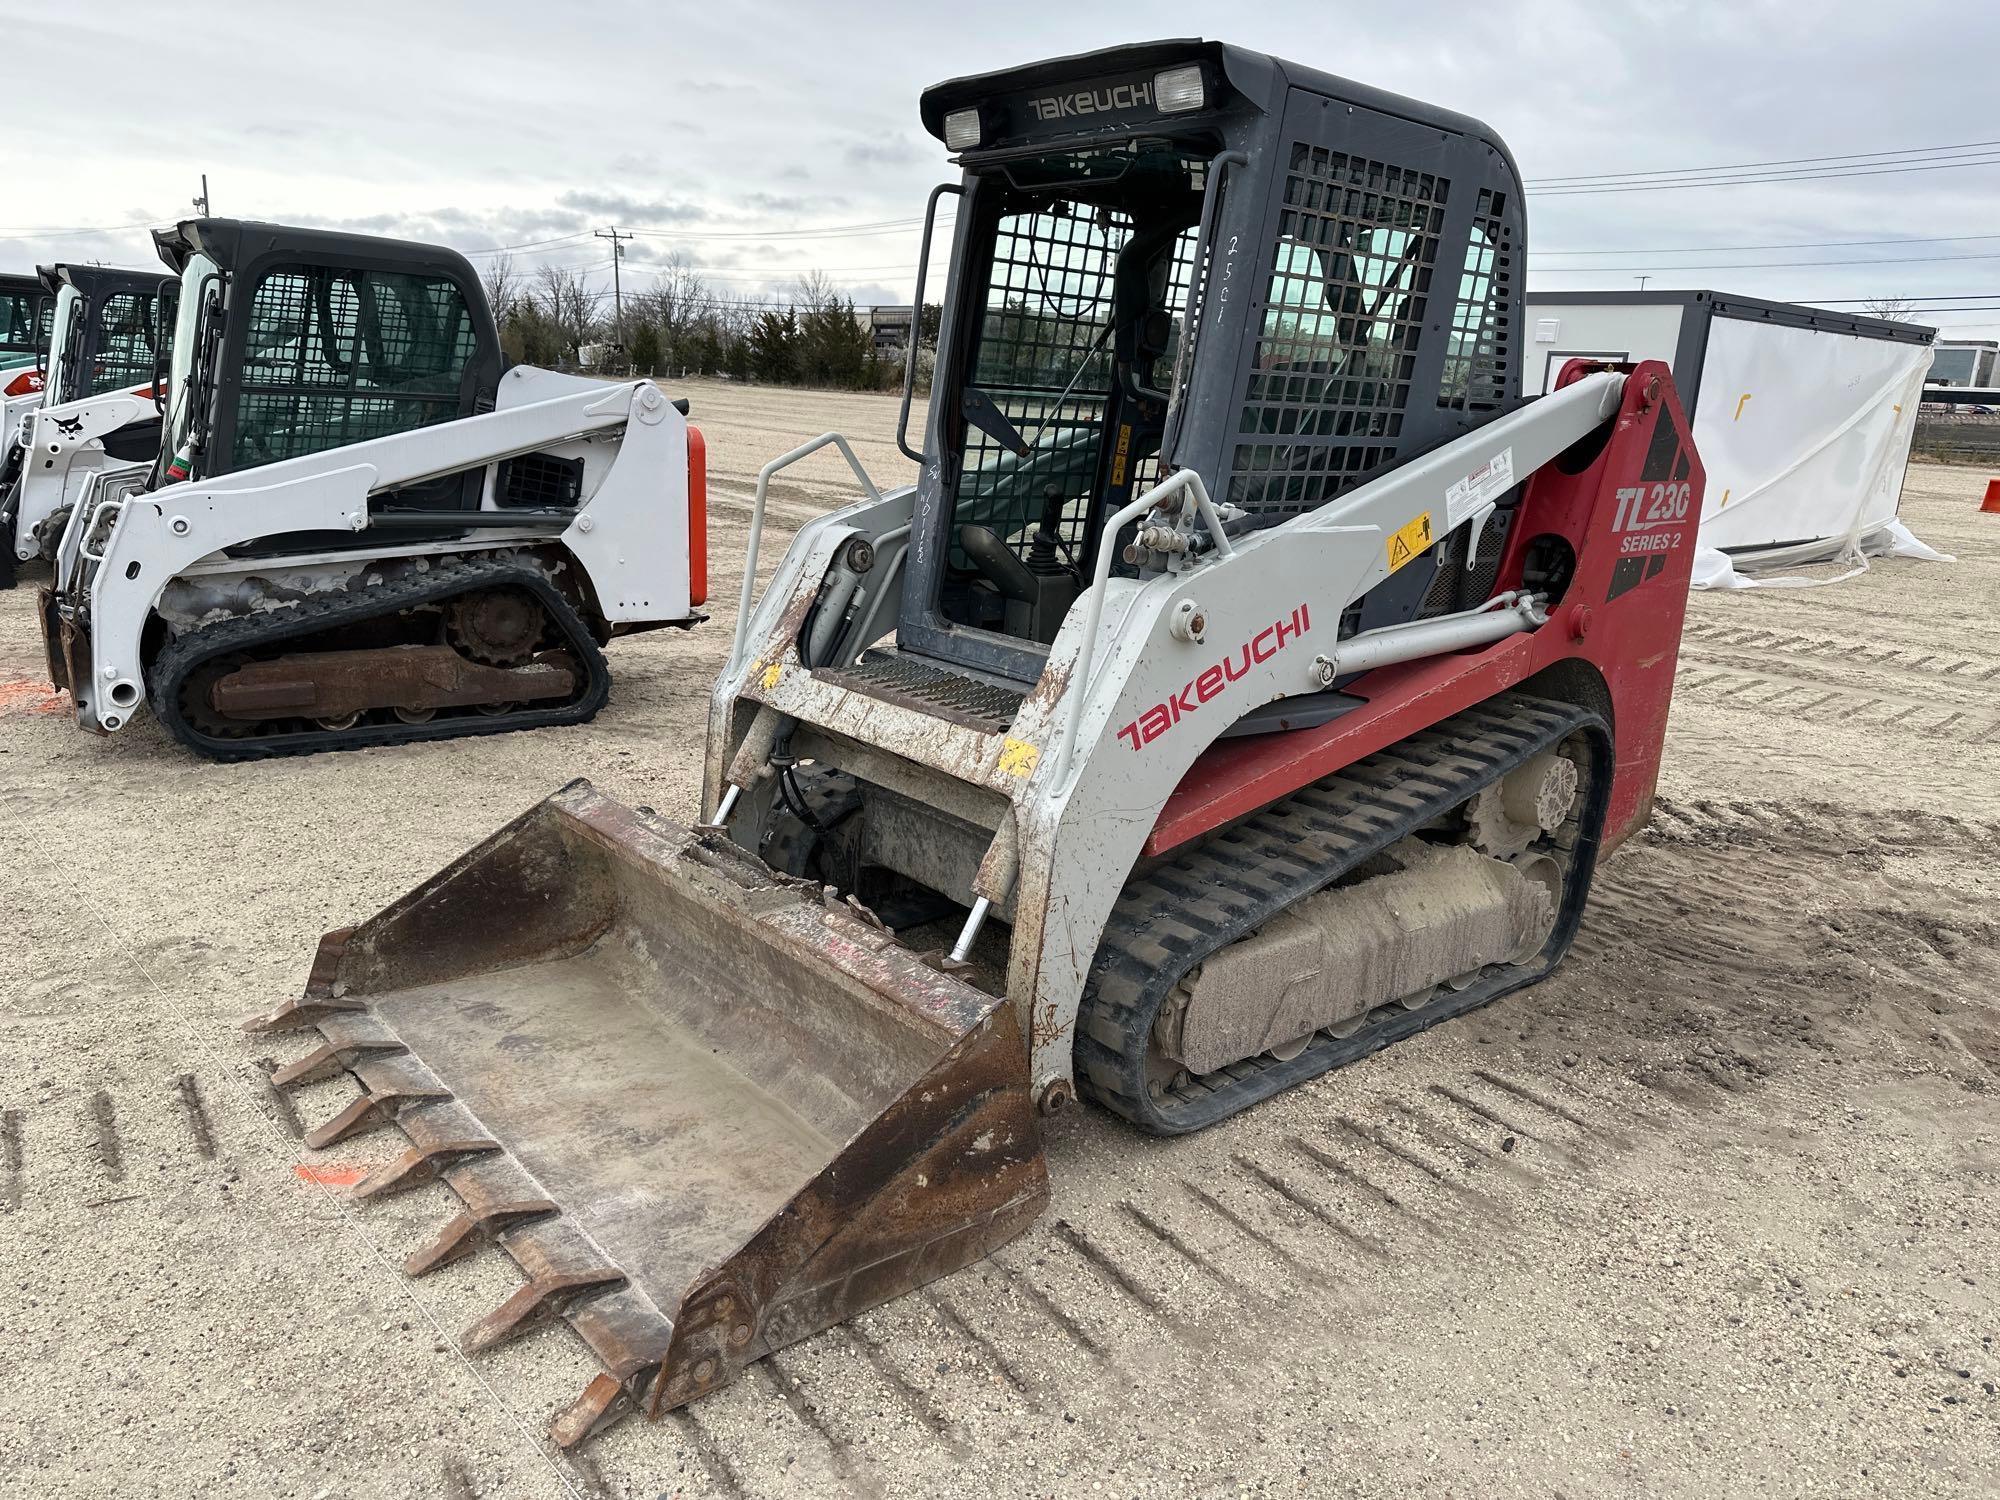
[0,386,2000,1500]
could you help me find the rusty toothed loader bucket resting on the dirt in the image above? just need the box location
[246,782,1048,1446]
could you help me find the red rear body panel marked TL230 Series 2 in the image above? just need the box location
[1146,360,1704,854]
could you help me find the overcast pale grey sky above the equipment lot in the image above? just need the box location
[0,0,2000,338]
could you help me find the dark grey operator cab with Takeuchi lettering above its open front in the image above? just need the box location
[898,40,1522,686]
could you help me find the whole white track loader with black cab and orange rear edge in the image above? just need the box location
[32,220,706,760]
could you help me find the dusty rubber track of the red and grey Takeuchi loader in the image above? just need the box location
[1076,694,1612,1134]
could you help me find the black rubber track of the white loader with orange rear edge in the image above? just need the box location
[146,558,612,760]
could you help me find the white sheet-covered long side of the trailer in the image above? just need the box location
[1694,318,1930,560]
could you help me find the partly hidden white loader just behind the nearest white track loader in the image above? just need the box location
[0,264,174,586]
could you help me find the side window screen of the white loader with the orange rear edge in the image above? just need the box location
[232,266,478,468]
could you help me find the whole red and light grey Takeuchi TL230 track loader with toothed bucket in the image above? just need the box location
[262,42,1702,1444]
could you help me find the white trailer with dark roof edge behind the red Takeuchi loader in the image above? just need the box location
[1522,292,1938,588]
